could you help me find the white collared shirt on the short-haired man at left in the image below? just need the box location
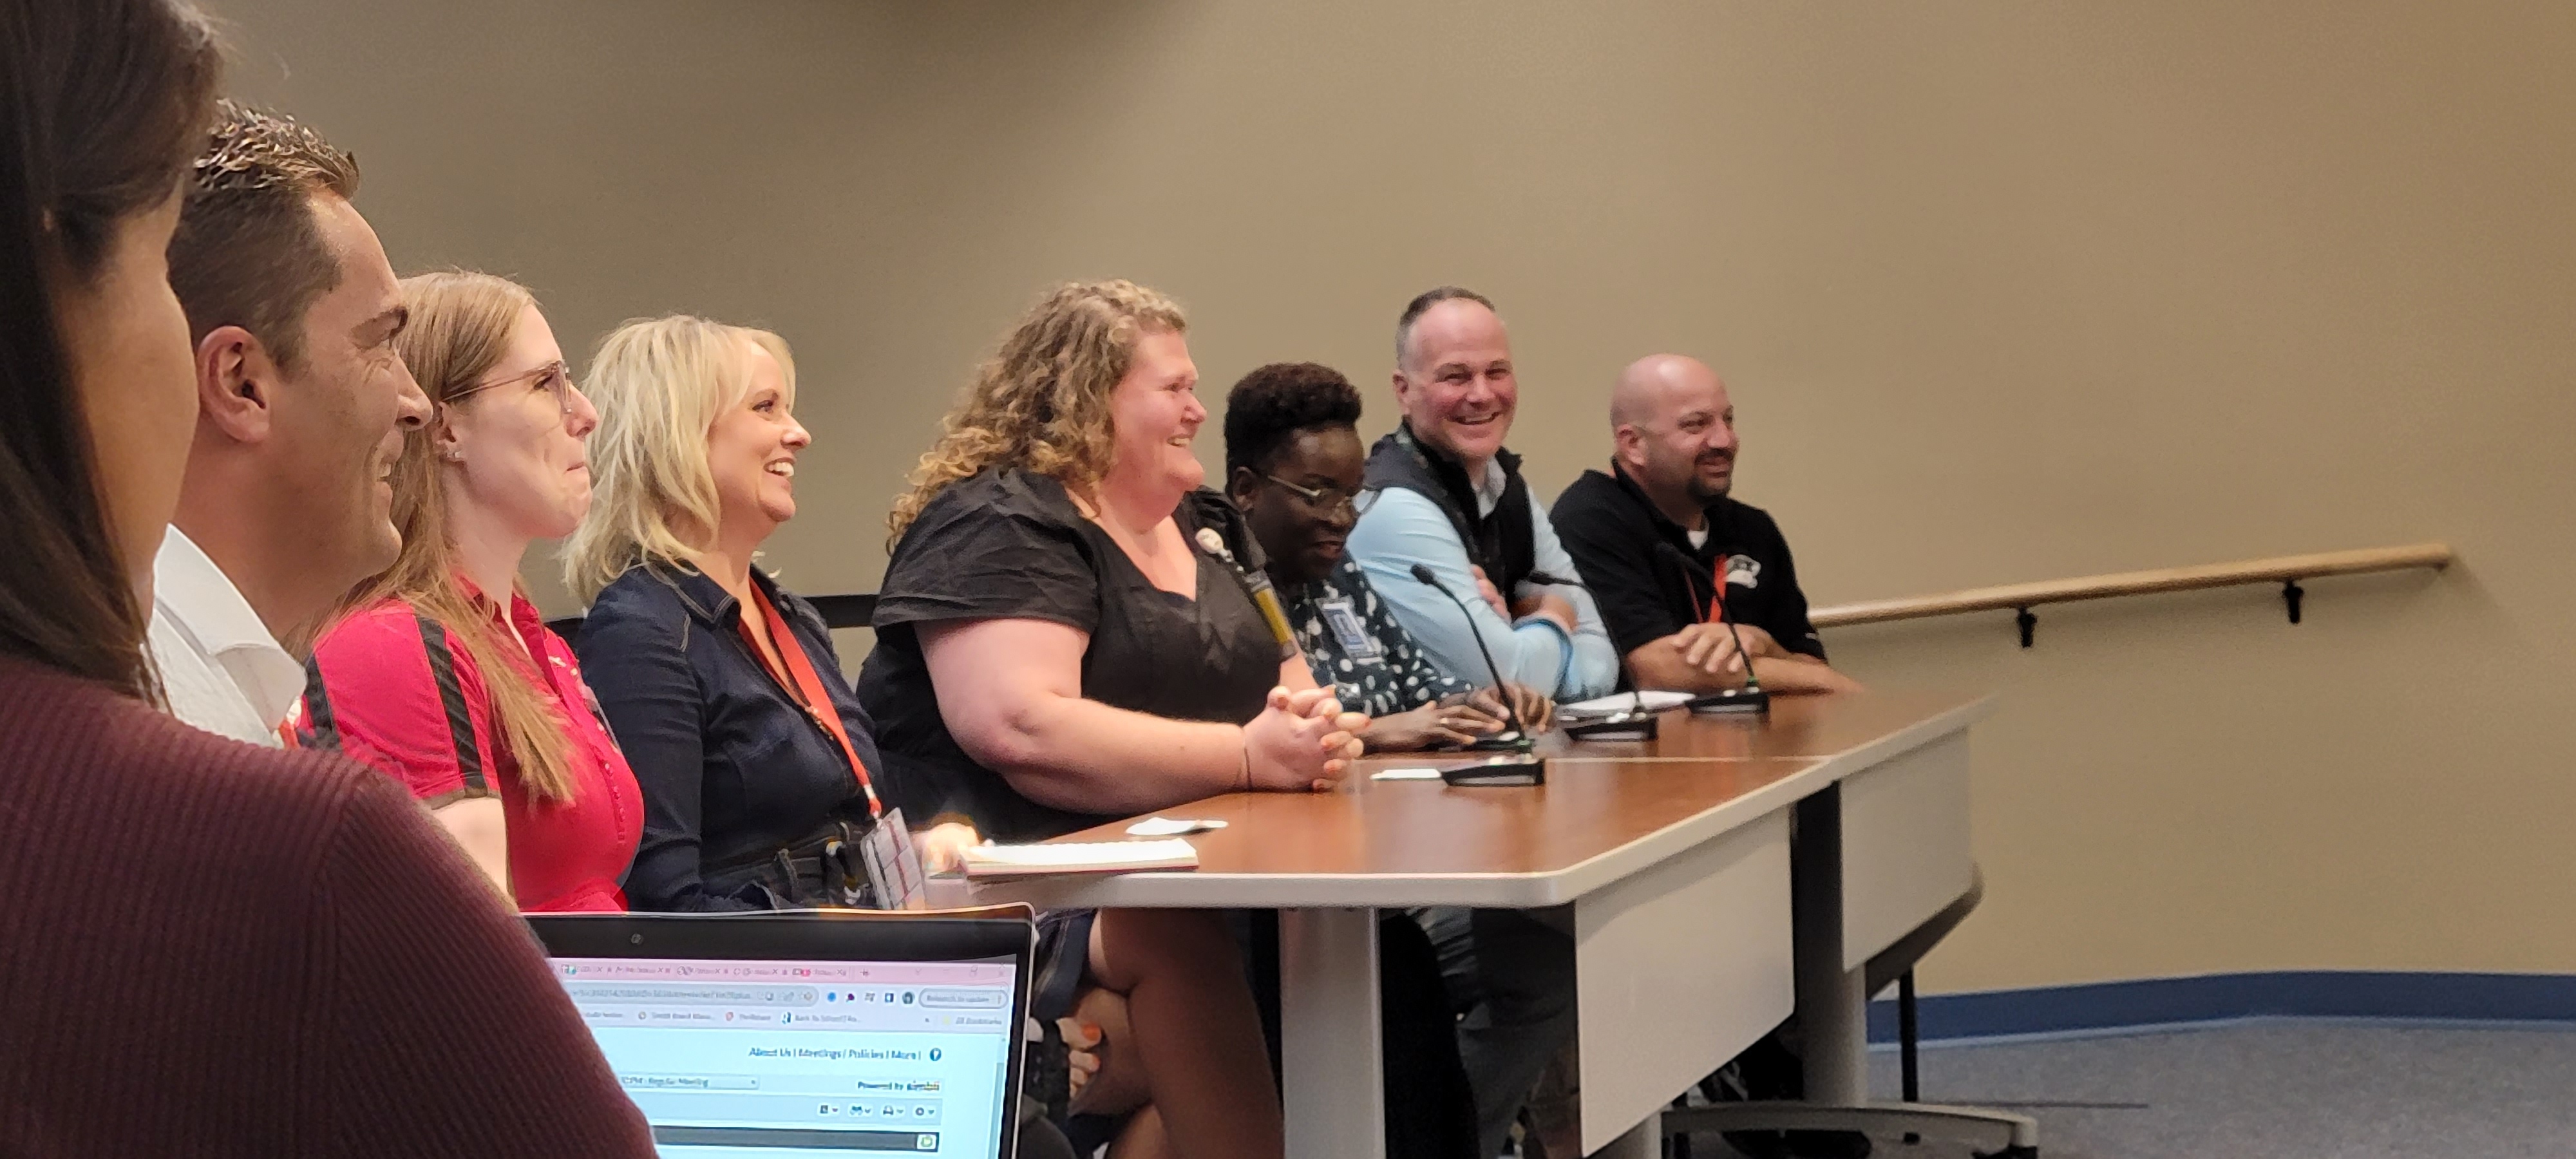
[152,528,304,747]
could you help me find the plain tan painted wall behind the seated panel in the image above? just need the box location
[216,0,2576,989]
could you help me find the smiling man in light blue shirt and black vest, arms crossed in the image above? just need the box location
[1345,286,1618,1159]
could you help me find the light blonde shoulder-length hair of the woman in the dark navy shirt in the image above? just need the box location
[564,314,796,605]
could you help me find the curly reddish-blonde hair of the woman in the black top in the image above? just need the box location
[886,278,1190,551]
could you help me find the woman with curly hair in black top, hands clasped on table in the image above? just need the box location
[858,281,1368,1156]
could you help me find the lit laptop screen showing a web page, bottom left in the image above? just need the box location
[554,958,1020,1159]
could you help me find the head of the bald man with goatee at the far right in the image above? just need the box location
[1610,353,1736,528]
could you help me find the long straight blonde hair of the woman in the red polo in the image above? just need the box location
[332,270,572,801]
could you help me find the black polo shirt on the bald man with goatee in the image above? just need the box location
[1548,464,1824,659]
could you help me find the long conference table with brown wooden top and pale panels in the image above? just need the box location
[976,690,1991,1159]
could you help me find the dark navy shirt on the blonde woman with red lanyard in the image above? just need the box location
[572,567,886,909]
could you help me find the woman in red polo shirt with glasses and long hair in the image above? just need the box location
[299,273,644,912]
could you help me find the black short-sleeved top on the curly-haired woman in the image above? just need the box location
[858,469,1280,840]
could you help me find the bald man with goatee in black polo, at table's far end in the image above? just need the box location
[1548,353,1860,693]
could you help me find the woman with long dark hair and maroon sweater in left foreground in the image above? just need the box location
[0,0,652,1156]
